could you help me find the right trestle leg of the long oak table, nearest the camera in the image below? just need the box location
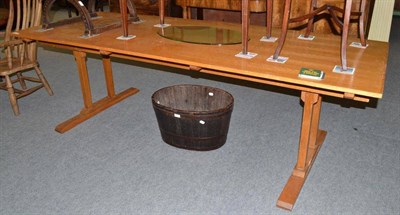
[276,91,327,210]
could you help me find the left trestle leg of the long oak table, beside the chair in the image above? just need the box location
[55,51,139,133]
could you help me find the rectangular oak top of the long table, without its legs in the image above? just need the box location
[14,13,389,98]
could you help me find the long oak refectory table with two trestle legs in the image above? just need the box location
[17,13,388,210]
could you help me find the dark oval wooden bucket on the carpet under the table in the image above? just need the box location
[152,85,234,151]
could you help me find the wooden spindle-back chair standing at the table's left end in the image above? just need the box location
[0,0,53,116]
